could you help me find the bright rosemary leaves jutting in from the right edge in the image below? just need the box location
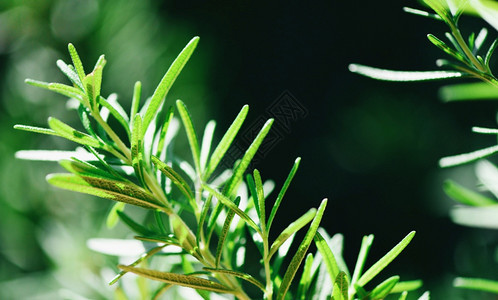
[349,0,498,294]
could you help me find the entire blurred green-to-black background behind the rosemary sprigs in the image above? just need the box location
[0,0,498,299]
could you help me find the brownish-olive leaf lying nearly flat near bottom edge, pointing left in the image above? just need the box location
[118,265,234,294]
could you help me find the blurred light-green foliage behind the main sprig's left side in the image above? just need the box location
[0,0,210,299]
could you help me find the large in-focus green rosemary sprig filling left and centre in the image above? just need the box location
[15,37,422,300]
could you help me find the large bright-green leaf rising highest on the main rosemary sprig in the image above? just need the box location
[143,36,199,132]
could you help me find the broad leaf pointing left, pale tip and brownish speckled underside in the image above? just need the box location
[47,174,161,209]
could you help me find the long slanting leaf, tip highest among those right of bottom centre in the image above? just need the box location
[277,199,327,300]
